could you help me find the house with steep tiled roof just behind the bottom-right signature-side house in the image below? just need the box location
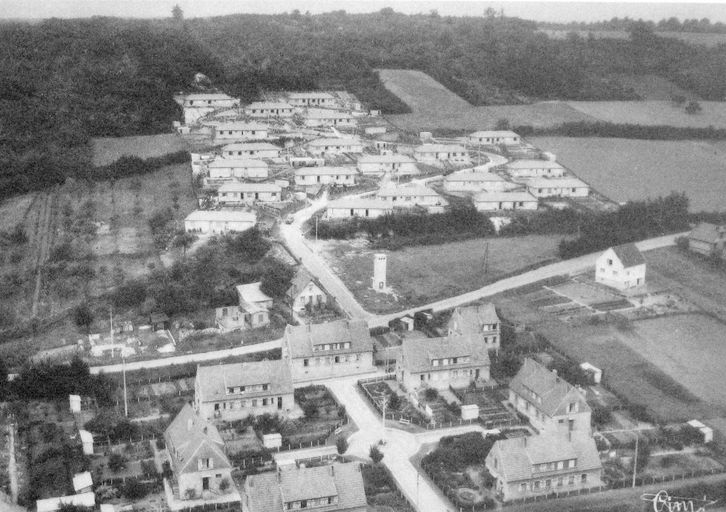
[509,357,591,436]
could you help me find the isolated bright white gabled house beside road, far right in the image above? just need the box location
[595,244,645,290]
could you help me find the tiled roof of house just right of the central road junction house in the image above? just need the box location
[401,334,489,373]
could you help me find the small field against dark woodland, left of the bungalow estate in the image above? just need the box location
[91,133,187,165]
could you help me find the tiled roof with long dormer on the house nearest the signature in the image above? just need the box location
[487,433,602,483]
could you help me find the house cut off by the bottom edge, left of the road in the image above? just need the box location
[242,462,368,512]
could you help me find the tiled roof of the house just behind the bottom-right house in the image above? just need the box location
[509,357,590,417]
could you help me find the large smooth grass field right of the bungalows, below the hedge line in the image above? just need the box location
[529,137,726,211]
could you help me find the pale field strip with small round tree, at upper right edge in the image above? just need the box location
[567,101,726,128]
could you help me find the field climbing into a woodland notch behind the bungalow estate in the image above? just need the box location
[379,69,594,131]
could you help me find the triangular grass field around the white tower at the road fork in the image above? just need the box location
[322,236,561,312]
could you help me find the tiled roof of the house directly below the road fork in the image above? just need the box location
[285,320,373,359]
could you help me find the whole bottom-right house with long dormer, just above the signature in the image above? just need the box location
[485,433,603,502]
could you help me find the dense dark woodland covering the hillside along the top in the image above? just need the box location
[0,8,726,198]
